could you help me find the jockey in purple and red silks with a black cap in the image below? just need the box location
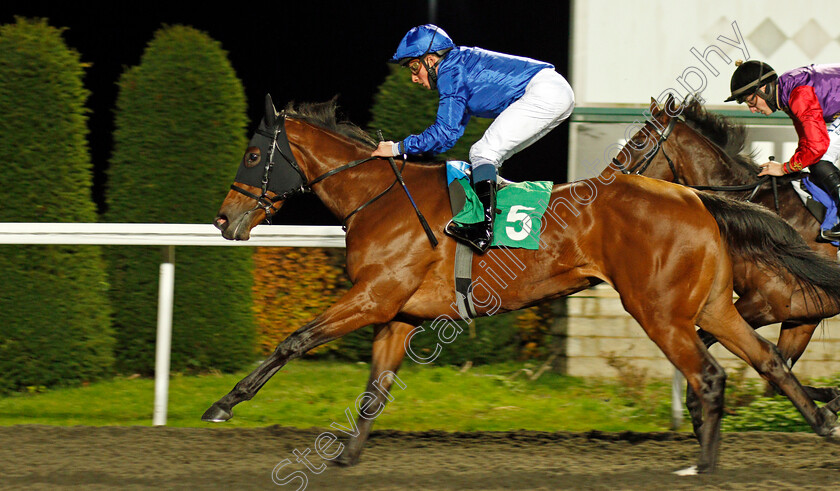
[725,60,840,241]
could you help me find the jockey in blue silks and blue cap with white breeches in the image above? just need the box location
[371,24,575,253]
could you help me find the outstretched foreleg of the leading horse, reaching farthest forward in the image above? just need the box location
[201,283,402,422]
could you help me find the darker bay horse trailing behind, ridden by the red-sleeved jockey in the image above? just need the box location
[602,97,840,412]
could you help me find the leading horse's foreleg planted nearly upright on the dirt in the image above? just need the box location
[335,321,414,465]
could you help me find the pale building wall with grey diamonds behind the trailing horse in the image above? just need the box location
[568,0,840,181]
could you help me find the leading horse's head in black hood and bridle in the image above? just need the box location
[213,95,307,240]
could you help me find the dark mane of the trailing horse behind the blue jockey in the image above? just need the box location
[682,100,759,182]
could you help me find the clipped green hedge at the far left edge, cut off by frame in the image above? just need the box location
[0,19,114,392]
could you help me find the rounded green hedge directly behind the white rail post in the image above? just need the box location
[105,26,255,374]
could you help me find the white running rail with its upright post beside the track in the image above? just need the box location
[0,223,344,426]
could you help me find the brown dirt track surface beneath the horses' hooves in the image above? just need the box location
[0,426,840,490]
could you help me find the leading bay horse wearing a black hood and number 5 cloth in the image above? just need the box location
[202,97,840,472]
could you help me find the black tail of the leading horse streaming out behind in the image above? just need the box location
[697,192,840,312]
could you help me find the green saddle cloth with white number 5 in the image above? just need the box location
[452,178,554,250]
